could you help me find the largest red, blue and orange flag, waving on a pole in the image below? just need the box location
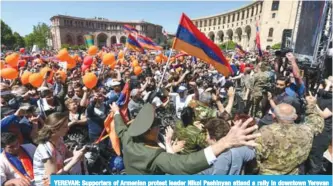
[172,13,232,76]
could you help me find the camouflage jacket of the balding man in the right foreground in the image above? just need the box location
[256,105,324,175]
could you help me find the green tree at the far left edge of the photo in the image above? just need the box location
[1,20,25,49]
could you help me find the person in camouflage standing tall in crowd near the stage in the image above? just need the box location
[250,71,270,118]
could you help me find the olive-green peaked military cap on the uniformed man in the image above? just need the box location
[128,104,155,137]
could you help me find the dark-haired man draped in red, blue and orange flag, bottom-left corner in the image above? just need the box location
[0,132,36,186]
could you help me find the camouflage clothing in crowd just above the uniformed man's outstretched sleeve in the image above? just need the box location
[174,122,207,154]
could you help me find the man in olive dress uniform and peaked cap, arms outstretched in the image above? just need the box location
[111,103,260,174]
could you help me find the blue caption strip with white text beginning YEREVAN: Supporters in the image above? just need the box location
[51,175,332,186]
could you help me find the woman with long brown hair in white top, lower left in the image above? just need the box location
[33,112,85,185]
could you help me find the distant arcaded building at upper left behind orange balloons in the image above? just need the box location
[51,15,165,49]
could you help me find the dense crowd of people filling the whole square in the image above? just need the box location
[0,44,333,186]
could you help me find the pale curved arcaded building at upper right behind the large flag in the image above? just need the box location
[192,0,298,50]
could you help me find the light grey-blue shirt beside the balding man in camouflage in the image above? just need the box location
[198,146,255,175]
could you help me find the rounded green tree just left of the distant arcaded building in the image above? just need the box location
[24,23,51,48]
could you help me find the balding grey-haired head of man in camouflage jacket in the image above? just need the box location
[274,103,297,123]
